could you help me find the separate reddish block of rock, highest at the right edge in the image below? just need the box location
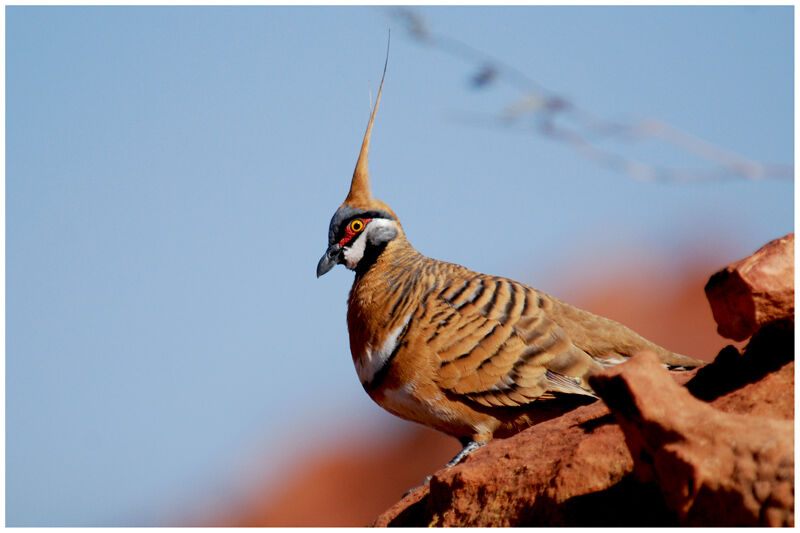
[705,233,794,341]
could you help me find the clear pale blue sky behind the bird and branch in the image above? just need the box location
[6,7,794,526]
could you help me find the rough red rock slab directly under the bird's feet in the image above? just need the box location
[373,366,694,527]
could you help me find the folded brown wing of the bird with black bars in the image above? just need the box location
[429,274,600,406]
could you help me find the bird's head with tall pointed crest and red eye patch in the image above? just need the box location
[317,48,403,277]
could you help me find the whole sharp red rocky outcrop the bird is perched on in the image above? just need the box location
[373,236,794,526]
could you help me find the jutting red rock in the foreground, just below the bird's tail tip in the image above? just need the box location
[590,352,794,526]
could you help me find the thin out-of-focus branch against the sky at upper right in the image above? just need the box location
[391,7,794,182]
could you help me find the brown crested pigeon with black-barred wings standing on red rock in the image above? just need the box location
[317,56,705,466]
